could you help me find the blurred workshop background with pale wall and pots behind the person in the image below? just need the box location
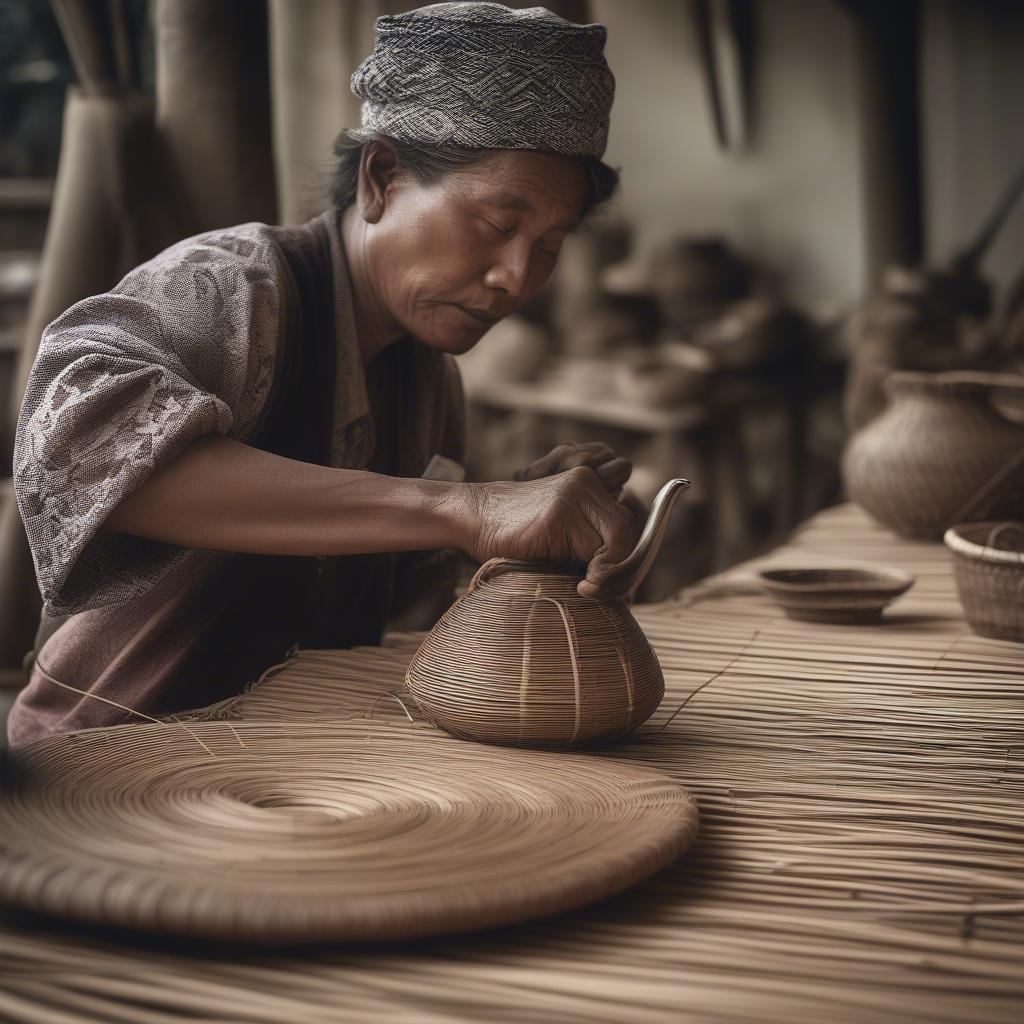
[0,0,1024,678]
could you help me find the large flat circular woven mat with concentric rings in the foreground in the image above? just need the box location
[0,722,697,944]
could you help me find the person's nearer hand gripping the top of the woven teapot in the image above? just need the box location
[465,466,639,597]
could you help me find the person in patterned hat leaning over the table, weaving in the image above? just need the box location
[9,3,636,744]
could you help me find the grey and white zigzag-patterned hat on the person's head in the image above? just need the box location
[352,3,615,157]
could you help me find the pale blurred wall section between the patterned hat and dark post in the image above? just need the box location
[592,0,866,308]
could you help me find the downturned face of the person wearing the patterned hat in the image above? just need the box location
[364,150,587,353]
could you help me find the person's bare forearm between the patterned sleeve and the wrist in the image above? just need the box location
[105,435,472,555]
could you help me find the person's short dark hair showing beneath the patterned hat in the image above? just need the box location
[330,128,618,217]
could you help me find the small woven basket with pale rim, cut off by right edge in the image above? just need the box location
[944,522,1024,643]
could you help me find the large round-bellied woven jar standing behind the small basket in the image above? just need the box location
[843,372,1024,540]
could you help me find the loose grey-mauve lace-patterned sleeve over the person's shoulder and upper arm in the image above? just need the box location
[13,224,287,614]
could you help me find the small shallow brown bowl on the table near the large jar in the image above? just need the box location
[760,568,913,626]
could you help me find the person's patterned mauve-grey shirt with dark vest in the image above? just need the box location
[8,207,463,744]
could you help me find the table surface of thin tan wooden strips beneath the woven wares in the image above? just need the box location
[0,507,1024,1024]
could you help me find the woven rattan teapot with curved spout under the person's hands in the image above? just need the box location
[406,480,689,746]
